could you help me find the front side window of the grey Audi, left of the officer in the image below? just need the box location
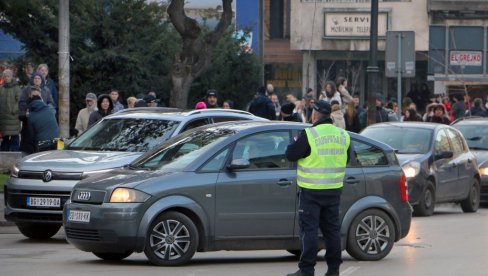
[232,131,292,170]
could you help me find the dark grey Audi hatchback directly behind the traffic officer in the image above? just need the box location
[63,121,412,265]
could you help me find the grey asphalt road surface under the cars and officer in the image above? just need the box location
[0,205,488,276]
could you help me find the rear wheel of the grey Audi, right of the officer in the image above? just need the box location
[346,209,396,261]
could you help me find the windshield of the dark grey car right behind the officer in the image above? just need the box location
[361,127,432,154]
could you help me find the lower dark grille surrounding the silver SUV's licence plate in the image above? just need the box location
[5,189,71,210]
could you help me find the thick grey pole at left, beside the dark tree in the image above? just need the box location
[57,0,69,138]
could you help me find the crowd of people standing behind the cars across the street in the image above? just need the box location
[0,63,488,154]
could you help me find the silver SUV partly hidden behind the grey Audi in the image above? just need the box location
[5,108,264,239]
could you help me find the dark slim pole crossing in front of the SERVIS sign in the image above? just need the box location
[366,0,380,126]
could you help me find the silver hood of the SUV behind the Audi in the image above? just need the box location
[17,150,142,172]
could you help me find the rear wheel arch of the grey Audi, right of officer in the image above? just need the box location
[341,196,401,249]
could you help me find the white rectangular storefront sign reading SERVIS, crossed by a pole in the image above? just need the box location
[324,11,388,39]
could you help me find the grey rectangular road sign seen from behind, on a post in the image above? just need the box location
[385,31,415,78]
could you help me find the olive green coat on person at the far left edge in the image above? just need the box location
[0,82,21,136]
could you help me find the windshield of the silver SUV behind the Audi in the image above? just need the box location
[66,118,180,152]
